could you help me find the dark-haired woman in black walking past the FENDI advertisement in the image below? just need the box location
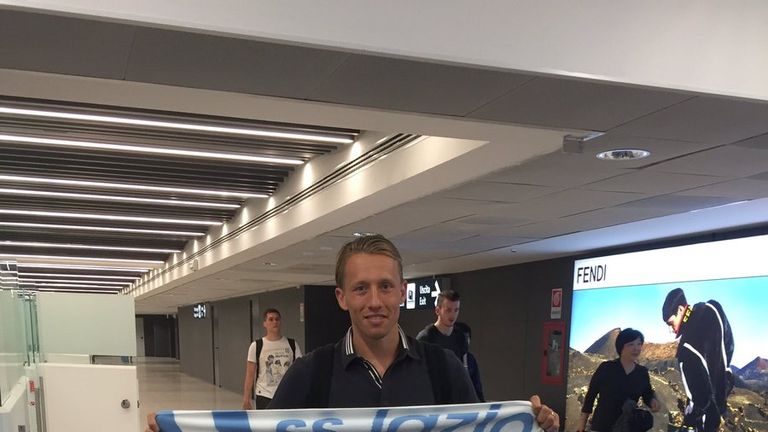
[577,328,661,432]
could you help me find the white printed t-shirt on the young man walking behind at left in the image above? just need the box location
[248,336,301,399]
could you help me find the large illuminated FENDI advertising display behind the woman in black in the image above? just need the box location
[565,236,768,432]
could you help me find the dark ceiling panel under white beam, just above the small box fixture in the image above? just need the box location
[468,77,691,131]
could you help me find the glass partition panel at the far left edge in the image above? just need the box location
[0,261,29,406]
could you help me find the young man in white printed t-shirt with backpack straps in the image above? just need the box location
[243,309,301,410]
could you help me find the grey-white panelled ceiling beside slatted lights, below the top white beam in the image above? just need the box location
[0,10,768,313]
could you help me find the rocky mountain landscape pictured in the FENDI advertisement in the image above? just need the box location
[565,328,768,432]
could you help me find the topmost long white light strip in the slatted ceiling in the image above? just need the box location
[0,107,354,144]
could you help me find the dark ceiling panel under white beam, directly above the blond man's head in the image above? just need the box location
[309,55,530,116]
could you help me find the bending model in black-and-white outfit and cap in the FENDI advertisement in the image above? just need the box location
[661,288,734,432]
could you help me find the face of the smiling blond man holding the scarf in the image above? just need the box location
[336,253,406,341]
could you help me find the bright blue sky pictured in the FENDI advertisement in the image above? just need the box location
[570,276,768,367]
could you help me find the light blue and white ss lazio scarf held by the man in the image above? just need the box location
[157,401,541,432]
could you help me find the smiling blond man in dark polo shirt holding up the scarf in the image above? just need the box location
[147,235,560,432]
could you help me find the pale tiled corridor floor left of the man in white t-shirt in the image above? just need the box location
[137,357,242,430]
